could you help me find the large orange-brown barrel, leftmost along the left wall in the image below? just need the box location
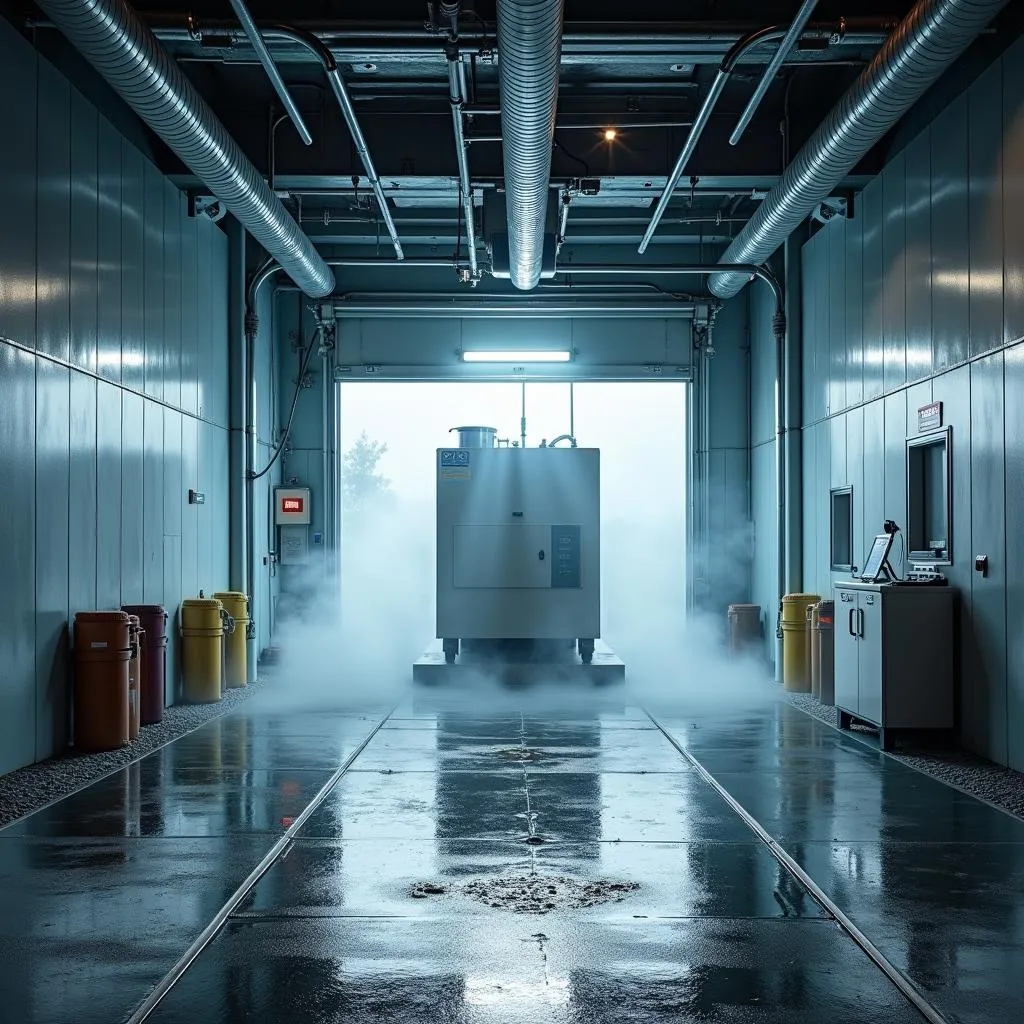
[75,611,131,752]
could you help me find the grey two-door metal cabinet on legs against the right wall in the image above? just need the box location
[835,583,954,750]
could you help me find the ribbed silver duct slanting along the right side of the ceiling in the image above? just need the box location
[709,0,1008,299]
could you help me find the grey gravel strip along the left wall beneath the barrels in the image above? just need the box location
[0,680,265,827]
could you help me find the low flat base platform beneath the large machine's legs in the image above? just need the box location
[413,640,626,685]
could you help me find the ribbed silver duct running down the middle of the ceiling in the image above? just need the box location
[498,0,564,291]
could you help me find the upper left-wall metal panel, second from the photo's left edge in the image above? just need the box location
[36,63,71,360]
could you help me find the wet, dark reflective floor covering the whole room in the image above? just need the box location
[0,689,1024,1024]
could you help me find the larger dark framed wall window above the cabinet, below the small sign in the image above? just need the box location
[906,427,953,564]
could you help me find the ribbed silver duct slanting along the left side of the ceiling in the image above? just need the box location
[34,0,334,298]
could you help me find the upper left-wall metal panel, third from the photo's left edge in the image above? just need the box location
[71,89,99,373]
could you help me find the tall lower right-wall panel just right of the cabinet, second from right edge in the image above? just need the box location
[961,352,1008,764]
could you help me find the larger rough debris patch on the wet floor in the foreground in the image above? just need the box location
[410,874,640,913]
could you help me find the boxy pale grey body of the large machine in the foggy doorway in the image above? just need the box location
[436,447,601,640]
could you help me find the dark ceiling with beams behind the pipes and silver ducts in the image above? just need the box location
[12,0,1013,282]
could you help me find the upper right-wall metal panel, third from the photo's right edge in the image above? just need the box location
[932,95,971,373]
